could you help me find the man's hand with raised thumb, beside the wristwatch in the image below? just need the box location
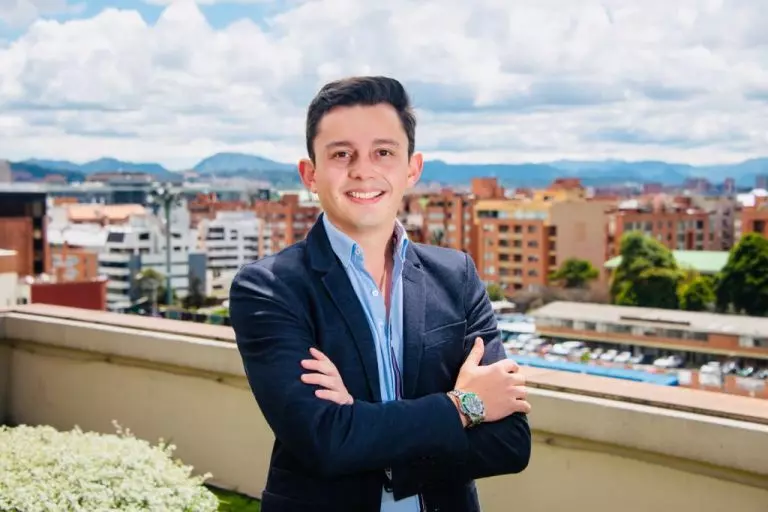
[454,337,531,424]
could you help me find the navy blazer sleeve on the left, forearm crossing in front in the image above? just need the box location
[229,263,469,477]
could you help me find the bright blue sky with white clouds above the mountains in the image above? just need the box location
[0,0,768,169]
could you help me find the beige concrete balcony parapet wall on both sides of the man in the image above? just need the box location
[0,305,768,512]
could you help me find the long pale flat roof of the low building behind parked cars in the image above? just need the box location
[529,301,768,338]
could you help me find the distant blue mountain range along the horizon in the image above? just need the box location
[10,153,768,187]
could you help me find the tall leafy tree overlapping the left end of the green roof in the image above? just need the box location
[611,231,684,309]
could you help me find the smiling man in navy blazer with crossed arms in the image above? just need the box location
[230,77,531,512]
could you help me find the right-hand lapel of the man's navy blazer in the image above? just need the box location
[403,248,427,398]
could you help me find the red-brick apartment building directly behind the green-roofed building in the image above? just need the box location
[606,195,722,260]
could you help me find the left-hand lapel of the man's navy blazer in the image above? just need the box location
[306,217,381,402]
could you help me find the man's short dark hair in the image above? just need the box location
[306,76,416,162]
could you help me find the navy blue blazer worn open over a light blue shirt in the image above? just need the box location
[229,221,531,512]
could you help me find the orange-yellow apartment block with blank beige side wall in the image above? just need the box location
[472,180,605,291]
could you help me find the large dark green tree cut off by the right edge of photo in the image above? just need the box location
[715,233,768,316]
